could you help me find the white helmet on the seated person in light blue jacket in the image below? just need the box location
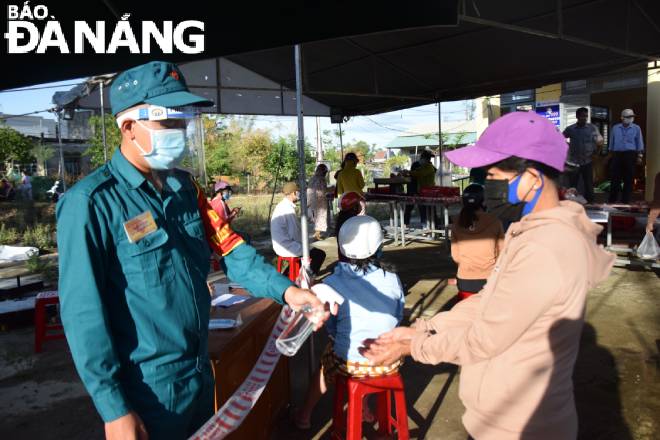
[338,215,383,260]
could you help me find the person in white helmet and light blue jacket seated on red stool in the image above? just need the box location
[295,215,405,429]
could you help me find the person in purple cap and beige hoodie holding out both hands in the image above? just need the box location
[363,112,614,440]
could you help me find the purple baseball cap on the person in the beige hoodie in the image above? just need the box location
[445,112,568,171]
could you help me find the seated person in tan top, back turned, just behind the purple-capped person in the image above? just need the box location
[451,183,504,299]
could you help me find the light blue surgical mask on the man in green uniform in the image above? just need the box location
[133,122,186,170]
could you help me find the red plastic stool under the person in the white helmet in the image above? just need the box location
[332,373,410,440]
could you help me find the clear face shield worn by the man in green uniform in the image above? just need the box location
[117,105,201,170]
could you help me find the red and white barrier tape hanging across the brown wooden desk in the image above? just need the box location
[190,306,294,440]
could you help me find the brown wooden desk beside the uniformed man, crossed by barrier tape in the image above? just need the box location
[209,289,289,440]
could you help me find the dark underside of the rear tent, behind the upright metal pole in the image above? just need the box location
[228,0,660,115]
